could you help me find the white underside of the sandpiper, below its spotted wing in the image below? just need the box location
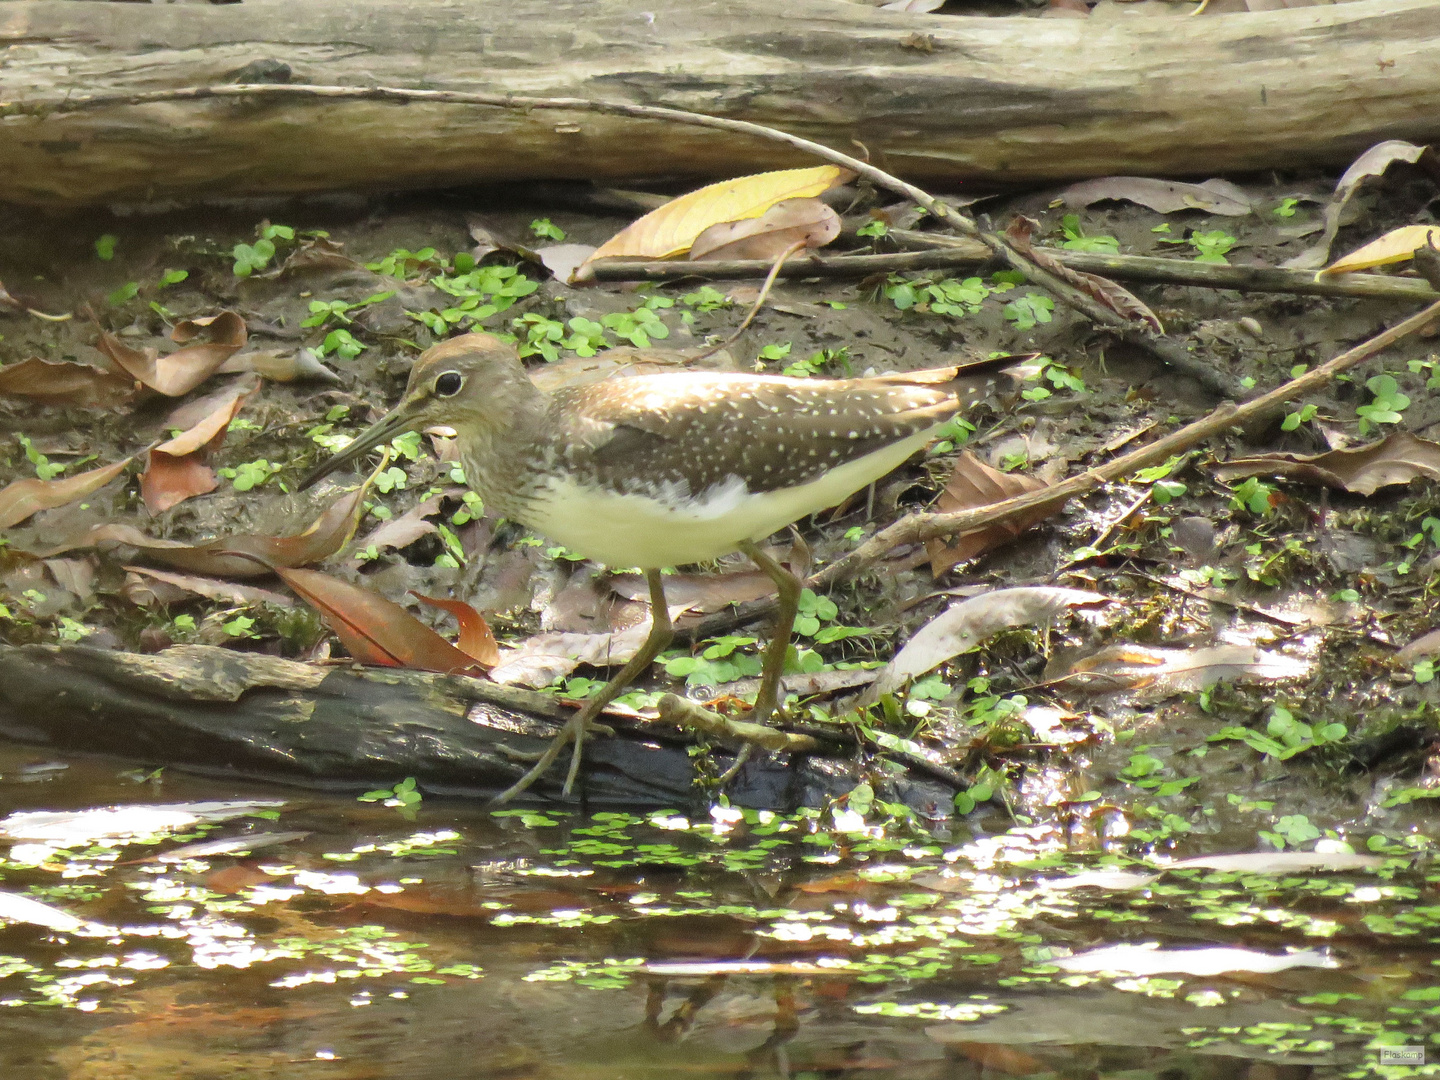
[524,425,939,569]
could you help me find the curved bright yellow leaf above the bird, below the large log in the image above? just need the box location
[576,166,854,279]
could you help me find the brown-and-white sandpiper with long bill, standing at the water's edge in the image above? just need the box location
[301,334,1014,801]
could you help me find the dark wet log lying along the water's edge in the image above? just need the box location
[0,645,904,812]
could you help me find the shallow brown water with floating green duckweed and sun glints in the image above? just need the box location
[0,747,1440,1080]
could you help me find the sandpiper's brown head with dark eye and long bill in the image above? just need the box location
[300,334,540,488]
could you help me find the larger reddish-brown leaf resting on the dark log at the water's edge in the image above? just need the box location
[275,566,489,674]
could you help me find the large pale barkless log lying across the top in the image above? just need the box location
[0,0,1440,206]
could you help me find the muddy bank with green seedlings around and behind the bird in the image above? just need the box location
[0,166,1440,850]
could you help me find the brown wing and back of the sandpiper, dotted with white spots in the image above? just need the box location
[553,373,962,495]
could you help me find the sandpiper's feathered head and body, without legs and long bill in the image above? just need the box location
[300,334,988,563]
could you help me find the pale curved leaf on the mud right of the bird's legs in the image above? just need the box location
[863,586,1109,701]
